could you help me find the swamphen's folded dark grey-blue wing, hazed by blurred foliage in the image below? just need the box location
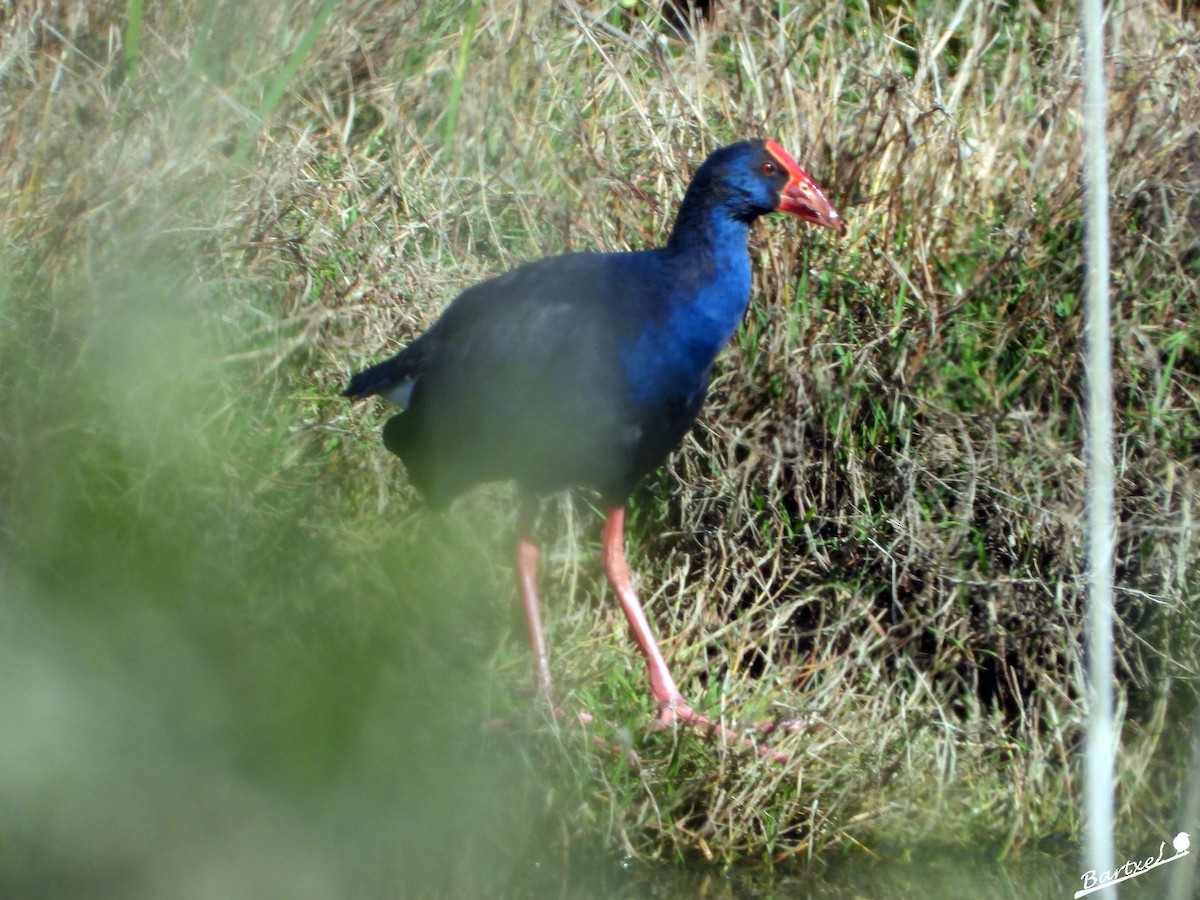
[389,254,641,496]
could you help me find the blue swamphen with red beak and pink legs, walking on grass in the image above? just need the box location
[346,140,842,758]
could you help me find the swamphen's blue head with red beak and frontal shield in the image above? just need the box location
[696,140,844,229]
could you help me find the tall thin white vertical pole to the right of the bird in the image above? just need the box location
[1082,0,1116,898]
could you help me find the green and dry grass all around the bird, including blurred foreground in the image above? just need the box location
[0,0,1200,896]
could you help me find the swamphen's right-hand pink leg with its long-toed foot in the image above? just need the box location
[604,506,790,762]
